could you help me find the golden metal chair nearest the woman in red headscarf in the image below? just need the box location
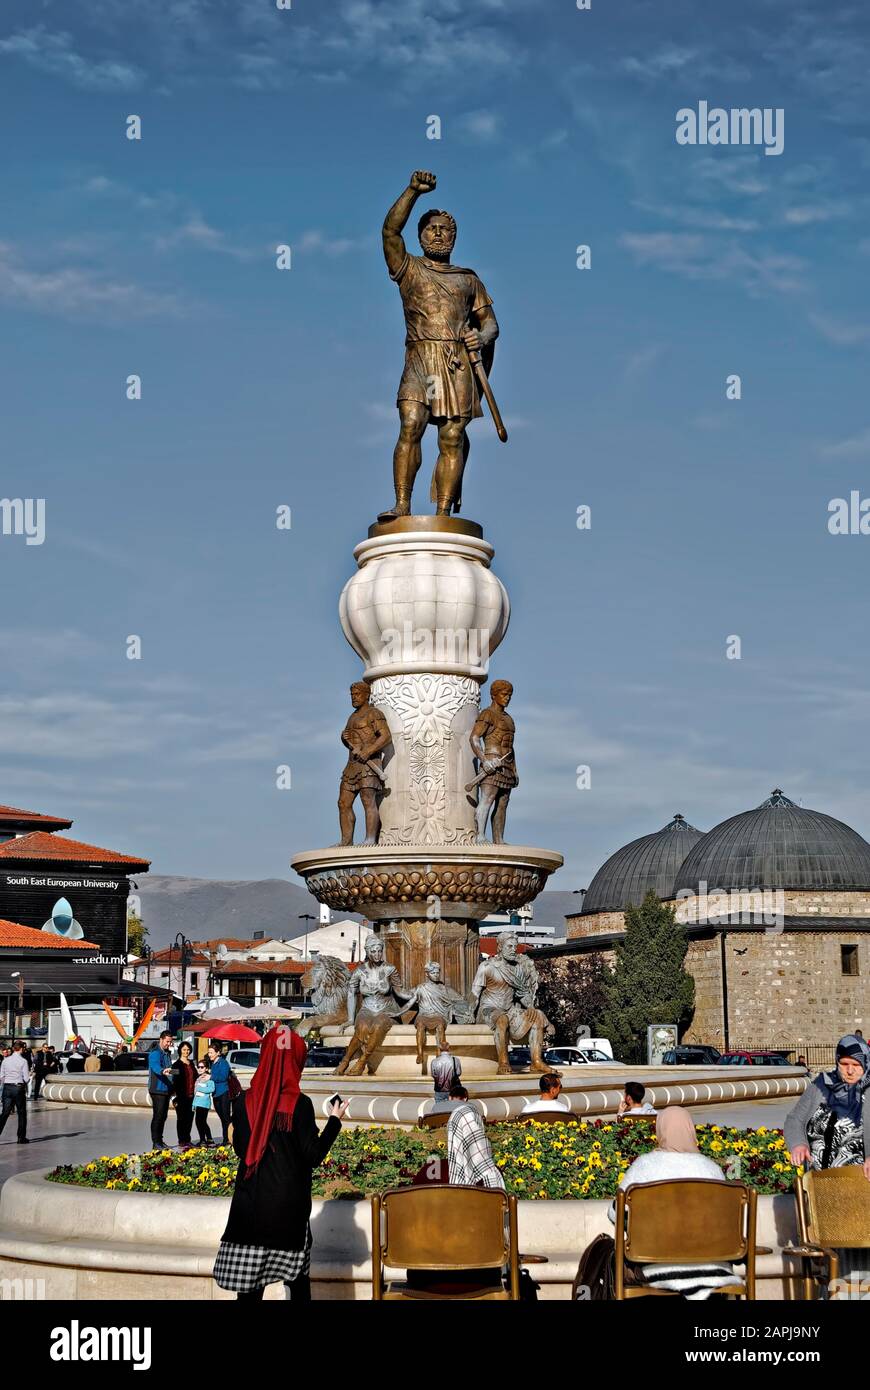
[371,1186,520,1301]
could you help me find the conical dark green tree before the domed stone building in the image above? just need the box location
[603,891,695,1061]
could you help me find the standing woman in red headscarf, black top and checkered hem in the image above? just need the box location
[214,1027,347,1301]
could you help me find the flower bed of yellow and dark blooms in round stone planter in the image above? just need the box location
[47,1119,796,1200]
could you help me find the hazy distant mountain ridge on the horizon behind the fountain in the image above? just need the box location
[136,874,572,949]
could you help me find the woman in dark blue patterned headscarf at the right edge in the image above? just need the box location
[784,1033,870,1180]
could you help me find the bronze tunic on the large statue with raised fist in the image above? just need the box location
[391,254,492,420]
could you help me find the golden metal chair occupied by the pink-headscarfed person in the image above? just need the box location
[614,1177,757,1300]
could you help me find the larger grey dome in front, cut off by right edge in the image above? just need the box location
[675,787,870,894]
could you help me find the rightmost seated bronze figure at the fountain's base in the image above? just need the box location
[471,931,553,1076]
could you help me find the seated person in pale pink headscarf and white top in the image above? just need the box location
[607,1105,734,1298]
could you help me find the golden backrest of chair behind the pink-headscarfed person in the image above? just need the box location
[617,1177,750,1265]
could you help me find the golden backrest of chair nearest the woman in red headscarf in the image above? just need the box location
[381,1186,516,1269]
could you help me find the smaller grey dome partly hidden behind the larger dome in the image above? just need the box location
[582,813,705,916]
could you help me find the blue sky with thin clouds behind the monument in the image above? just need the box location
[0,0,870,890]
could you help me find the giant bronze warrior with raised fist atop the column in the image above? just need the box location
[378,170,497,521]
